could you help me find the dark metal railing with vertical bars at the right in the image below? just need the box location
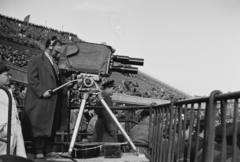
[149,91,240,162]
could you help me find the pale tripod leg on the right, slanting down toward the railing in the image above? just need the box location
[97,94,137,152]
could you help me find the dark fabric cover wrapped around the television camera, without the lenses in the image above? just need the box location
[58,42,112,76]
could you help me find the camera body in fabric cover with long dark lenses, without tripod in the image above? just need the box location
[58,42,144,77]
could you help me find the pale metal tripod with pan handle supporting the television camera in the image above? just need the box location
[53,77,139,157]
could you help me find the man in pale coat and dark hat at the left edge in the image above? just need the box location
[0,62,27,158]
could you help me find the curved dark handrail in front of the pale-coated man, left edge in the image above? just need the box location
[0,85,12,155]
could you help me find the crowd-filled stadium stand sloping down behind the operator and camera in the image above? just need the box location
[0,15,192,100]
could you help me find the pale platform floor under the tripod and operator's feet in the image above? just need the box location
[47,153,149,162]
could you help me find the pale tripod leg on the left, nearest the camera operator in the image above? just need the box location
[68,93,88,157]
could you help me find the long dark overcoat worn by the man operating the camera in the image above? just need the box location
[22,53,68,137]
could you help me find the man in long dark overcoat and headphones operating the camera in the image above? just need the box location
[23,37,67,159]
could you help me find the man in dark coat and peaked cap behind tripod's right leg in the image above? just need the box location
[92,80,117,142]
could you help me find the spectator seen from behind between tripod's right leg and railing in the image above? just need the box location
[130,109,150,158]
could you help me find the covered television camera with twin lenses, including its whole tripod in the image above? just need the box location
[52,42,144,157]
